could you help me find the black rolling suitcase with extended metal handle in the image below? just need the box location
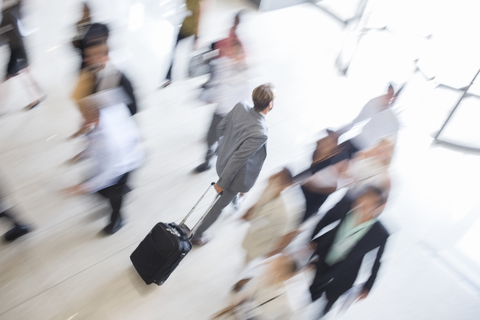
[130,182,221,286]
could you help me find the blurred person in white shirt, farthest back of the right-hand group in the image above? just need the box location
[335,85,401,156]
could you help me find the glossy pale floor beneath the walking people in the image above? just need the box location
[0,0,480,320]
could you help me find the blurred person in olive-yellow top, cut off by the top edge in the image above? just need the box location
[161,0,201,88]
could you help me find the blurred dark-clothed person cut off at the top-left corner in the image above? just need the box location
[0,0,45,110]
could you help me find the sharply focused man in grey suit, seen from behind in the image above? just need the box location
[192,84,275,245]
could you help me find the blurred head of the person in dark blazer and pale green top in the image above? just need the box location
[353,186,386,221]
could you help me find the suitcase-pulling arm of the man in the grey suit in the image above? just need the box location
[217,135,268,189]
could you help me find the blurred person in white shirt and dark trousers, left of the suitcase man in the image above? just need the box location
[66,103,144,234]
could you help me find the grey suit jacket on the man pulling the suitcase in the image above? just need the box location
[217,102,268,192]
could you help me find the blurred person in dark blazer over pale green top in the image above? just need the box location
[310,186,389,314]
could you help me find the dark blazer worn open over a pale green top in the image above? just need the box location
[310,197,390,299]
